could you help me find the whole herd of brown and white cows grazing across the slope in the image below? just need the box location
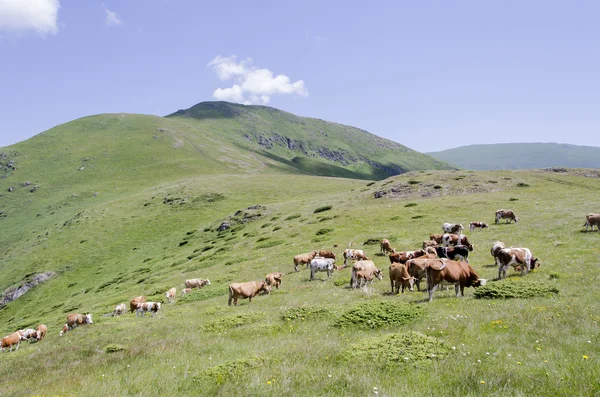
[1,210,600,351]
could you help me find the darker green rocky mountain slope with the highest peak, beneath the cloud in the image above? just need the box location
[167,102,453,179]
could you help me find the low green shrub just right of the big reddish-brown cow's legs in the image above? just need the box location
[473,281,558,299]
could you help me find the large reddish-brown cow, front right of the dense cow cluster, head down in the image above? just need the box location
[425,259,487,302]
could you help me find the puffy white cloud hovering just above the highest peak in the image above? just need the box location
[207,55,308,105]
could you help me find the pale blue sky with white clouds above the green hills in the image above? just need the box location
[0,0,600,151]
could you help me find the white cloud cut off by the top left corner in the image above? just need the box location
[0,0,60,36]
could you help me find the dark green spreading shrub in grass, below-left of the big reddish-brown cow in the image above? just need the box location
[333,301,425,328]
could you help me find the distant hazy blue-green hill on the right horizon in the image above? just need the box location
[427,143,600,170]
